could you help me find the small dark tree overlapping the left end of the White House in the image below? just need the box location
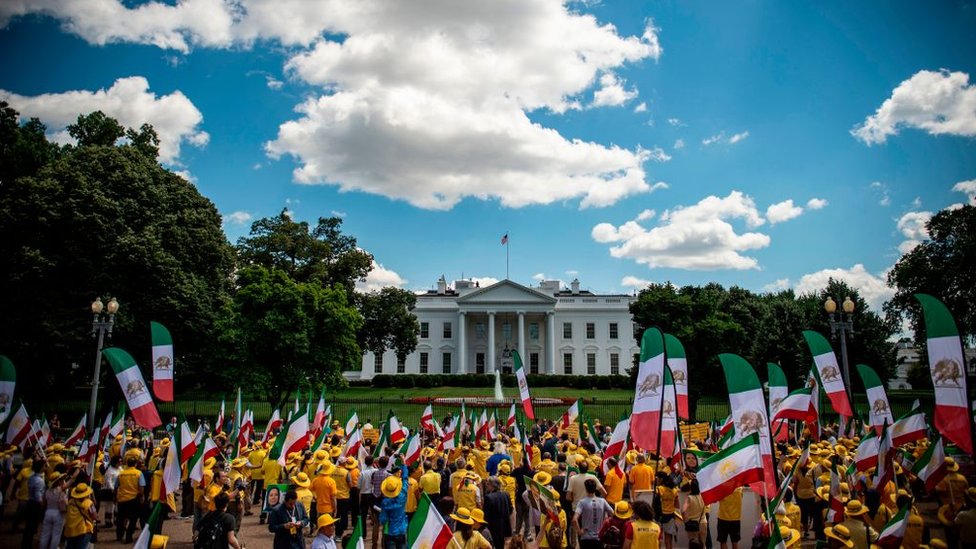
[356,287,420,360]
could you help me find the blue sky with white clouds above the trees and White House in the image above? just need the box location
[0,0,976,312]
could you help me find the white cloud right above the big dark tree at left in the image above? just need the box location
[0,76,210,165]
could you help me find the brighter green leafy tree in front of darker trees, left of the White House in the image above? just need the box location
[219,265,362,407]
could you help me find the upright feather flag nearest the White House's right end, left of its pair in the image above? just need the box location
[630,328,664,451]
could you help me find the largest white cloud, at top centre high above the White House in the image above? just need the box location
[266,4,661,209]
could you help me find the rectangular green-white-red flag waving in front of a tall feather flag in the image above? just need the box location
[696,433,775,505]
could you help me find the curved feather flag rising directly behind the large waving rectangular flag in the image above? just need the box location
[718,353,777,497]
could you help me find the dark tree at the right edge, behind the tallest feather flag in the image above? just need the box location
[885,205,976,342]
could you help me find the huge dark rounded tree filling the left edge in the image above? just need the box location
[0,111,234,402]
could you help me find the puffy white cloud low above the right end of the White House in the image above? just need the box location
[591,191,770,270]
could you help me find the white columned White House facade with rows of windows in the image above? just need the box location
[354,277,640,379]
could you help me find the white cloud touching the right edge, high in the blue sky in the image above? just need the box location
[851,69,976,145]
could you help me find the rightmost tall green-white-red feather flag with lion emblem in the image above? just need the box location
[915,294,973,455]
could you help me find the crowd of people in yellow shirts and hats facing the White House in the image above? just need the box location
[0,414,976,549]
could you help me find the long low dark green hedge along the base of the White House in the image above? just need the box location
[372,374,633,389]
